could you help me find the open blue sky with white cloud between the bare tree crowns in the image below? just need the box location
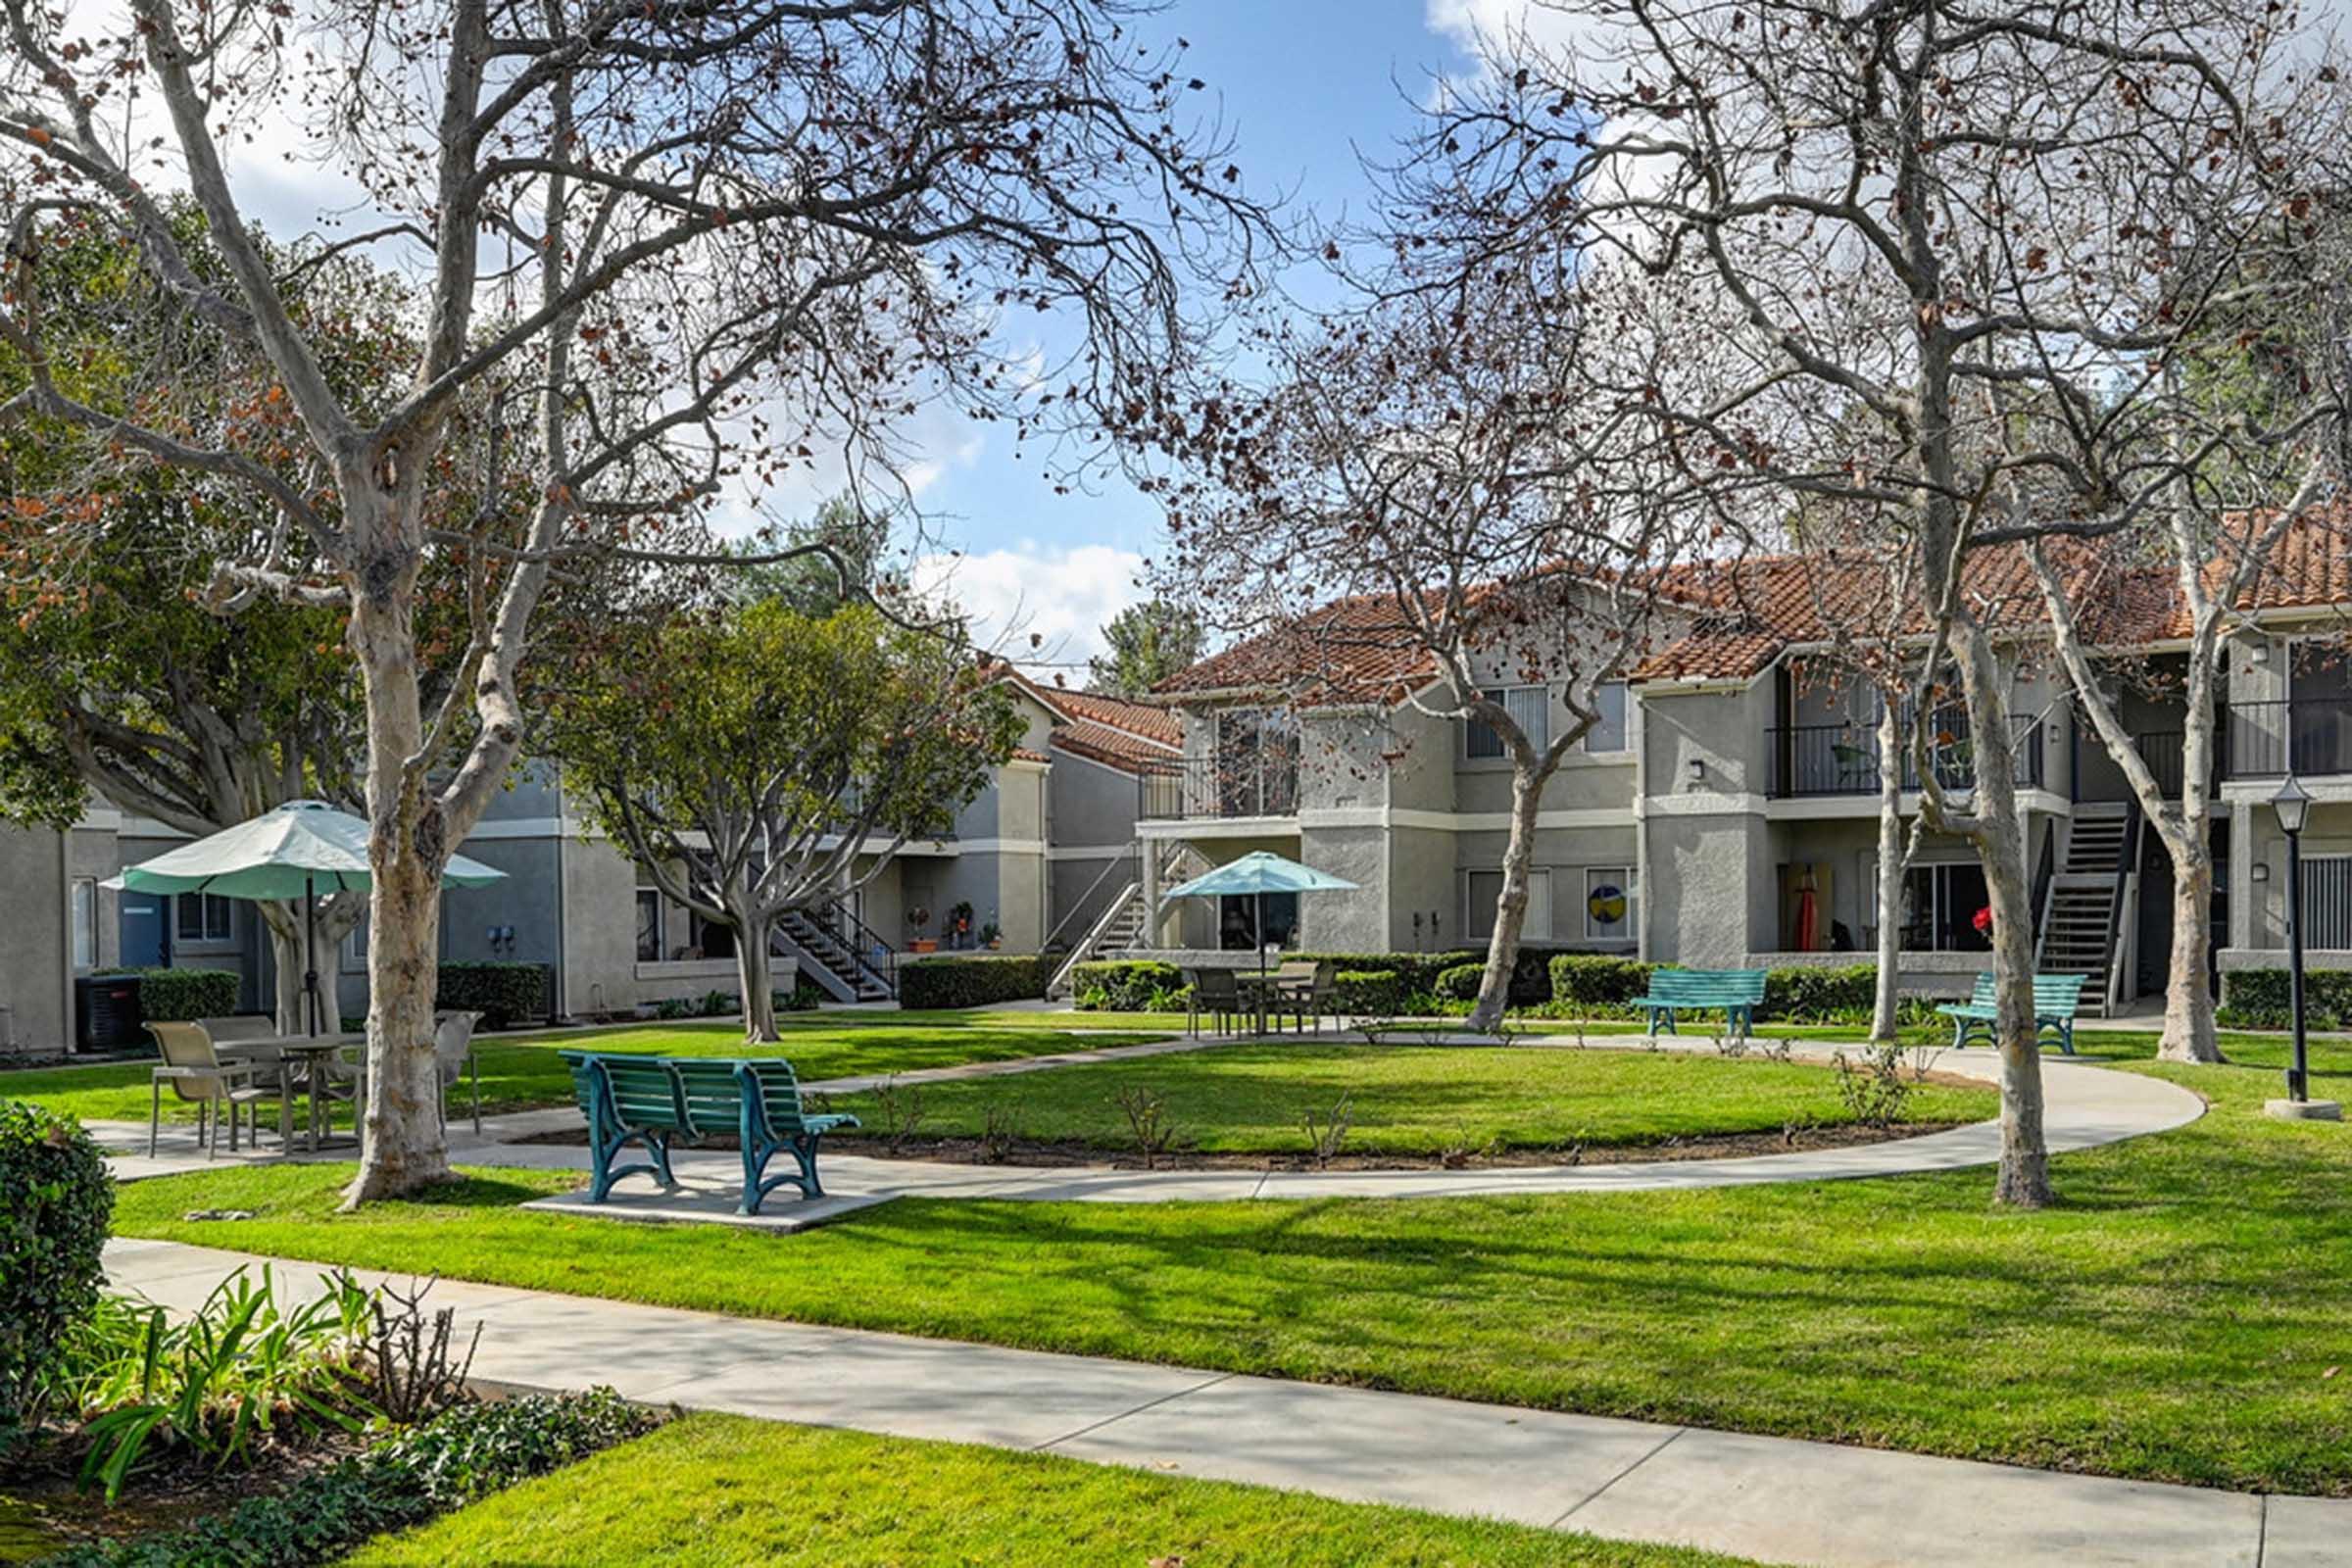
[898,0,1503,679]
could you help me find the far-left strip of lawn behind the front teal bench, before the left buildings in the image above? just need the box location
[0,1013,1162,1126]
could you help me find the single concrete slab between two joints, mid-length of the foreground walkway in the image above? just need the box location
[1052,1378,1677,1526]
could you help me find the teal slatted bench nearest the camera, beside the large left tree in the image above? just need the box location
[560,1051,858,1215]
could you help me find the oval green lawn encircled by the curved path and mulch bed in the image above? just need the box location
[835,1044,1999,1154]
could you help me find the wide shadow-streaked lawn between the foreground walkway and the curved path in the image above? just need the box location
[116,1046,2352,1495]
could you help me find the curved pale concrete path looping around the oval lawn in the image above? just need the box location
[92,1037,2204,1230]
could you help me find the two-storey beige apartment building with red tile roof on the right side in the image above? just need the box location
[1114,517,2352,1008]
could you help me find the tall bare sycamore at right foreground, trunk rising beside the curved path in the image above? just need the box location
[1428,0,2342,1206]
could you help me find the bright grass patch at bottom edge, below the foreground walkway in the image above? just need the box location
[343,1415,1768,1568]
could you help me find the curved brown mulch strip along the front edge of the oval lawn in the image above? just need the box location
[513,1121,1969,1171]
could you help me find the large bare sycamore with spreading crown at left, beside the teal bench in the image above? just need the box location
[0,0,1263,1203]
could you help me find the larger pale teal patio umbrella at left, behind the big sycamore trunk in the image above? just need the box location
[104,800,506,1034]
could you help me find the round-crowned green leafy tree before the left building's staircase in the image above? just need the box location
[546,597,1021,1042]
